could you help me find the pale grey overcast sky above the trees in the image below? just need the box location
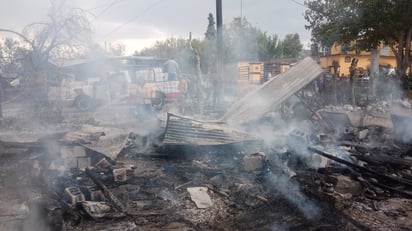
[0,0,310,55]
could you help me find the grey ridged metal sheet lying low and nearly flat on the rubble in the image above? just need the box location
[163,113,256,146]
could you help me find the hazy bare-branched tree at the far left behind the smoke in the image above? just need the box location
[0,0,91,102]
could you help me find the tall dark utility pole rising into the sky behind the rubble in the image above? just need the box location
[213,0,224,106]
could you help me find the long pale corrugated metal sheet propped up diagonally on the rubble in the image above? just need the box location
[221,57,323,125]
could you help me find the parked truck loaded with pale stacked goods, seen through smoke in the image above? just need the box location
[69,68,187,111]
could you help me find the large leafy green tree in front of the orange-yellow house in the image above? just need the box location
[305,0,412,96]
